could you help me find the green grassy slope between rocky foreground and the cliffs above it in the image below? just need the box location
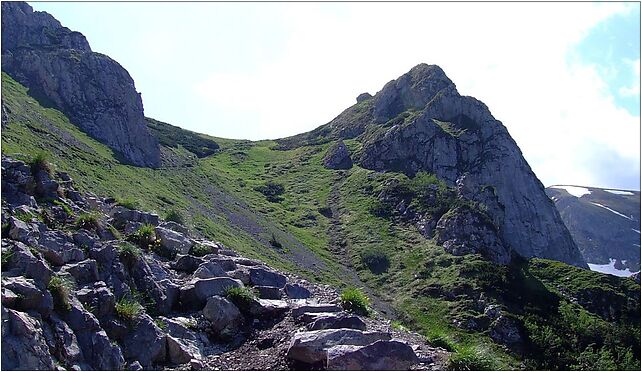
[2,74,639,369]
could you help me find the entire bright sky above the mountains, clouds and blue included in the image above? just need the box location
[30,2,640,190]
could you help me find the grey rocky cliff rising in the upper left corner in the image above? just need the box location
[2,2,160,167]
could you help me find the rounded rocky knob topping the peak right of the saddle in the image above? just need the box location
[373,63,456,123]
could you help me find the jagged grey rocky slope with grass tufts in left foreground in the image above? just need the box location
[2,158,447,370]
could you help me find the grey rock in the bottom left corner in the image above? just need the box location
[1,307,54,371]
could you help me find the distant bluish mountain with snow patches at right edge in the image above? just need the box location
[546,185,640,276]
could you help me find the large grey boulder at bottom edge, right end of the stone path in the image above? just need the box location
[326,340,419,371]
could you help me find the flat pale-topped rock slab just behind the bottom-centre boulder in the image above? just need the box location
[287,329,390,364]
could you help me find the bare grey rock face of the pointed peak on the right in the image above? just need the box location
[324,64,587,267]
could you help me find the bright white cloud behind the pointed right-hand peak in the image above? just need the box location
[190,3,640,189]
